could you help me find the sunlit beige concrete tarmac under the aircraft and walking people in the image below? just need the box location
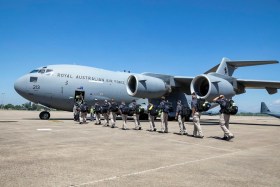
[0,110,280,187]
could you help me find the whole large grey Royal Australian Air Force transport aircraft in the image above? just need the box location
[14,58,280,119]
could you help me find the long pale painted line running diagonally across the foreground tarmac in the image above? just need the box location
[70,143,280,187]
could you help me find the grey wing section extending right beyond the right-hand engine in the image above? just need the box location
[237,79,280,94]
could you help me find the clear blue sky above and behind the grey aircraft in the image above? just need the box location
[0,0,280,112]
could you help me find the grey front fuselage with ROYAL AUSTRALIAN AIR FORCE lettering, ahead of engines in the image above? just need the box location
[14,65,138,111]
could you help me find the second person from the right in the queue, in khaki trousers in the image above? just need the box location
[191,92,204,138]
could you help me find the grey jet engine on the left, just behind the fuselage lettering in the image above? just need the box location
[126,74,170,98]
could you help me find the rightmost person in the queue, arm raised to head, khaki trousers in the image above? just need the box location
[213,95,234,141]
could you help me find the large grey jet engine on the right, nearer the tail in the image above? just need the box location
[191,74,236,102]
